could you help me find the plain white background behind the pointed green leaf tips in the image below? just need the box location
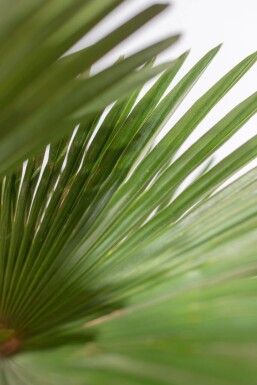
[77,0,257,170]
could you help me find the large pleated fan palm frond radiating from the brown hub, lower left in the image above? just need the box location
[0,37,257,385]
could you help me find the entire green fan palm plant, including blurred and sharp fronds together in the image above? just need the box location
[0,0,257,385]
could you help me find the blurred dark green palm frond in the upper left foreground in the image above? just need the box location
[0,0,178,175]
